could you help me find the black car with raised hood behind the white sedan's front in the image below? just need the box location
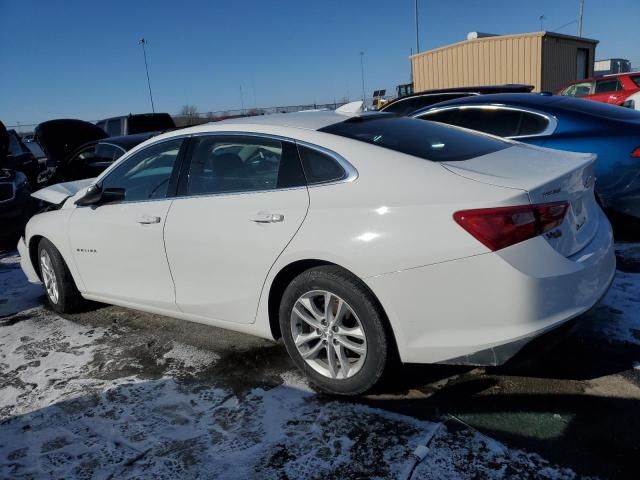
[36,119,157,183]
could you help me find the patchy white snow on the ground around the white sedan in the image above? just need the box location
[0,246,640,480]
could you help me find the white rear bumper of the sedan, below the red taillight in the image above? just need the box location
[366,212,615,365]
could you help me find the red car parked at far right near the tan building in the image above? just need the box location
[558,72,640,105]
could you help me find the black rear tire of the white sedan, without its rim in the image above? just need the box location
[279,266,394,395]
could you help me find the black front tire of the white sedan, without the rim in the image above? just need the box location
[37,238,86,313]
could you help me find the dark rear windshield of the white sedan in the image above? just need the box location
[320,115,511,162]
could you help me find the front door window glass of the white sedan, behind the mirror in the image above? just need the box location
[101,138,183,202]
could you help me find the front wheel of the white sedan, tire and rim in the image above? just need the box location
[38,238,84,313]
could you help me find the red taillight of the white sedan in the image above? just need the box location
[453,202,569,252]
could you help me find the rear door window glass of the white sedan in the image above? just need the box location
[187,135,305,195]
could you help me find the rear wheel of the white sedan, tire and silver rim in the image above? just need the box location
[280,266,390,395]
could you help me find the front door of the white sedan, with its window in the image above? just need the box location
[69,138,183,311]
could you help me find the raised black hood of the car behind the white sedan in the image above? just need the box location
[35,119,108,164]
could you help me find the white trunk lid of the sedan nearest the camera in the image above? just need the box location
[442,144,600,257]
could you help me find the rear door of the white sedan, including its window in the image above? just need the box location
[165,134,309,323]
